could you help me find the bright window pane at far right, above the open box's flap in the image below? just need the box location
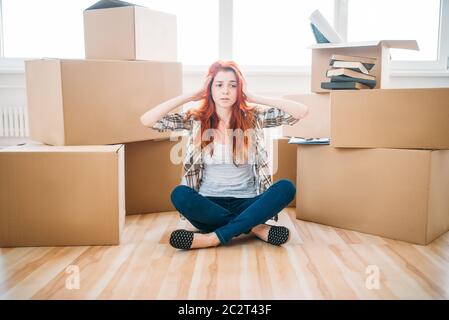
[348,0,440,60]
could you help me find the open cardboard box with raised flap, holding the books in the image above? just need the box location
[309,40,419,92]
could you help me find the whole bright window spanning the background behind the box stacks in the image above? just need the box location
[0,0,449,73]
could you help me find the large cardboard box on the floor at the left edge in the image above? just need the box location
[0,145,125,247]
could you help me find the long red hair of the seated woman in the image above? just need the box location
[187,60,254,165]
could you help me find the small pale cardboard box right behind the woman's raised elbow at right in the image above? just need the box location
[282,93,331,138]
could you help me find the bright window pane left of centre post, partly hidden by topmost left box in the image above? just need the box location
[2,0,218,64]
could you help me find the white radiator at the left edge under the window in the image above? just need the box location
[0,106,28,137]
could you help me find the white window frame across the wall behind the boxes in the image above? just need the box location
[0,0,449,76]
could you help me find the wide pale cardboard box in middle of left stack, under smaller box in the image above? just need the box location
[25,59,182,145]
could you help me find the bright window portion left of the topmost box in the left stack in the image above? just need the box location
[2,0,92,58]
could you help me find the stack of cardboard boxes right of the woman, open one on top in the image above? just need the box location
[283,41,449,245]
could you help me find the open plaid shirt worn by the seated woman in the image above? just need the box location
[152,106,299,221]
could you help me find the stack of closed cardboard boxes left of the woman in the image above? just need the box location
[0,1,182,247]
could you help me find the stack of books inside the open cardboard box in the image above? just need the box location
[321,54,376,90]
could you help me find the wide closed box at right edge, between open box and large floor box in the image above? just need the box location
[331,88,449,149]
